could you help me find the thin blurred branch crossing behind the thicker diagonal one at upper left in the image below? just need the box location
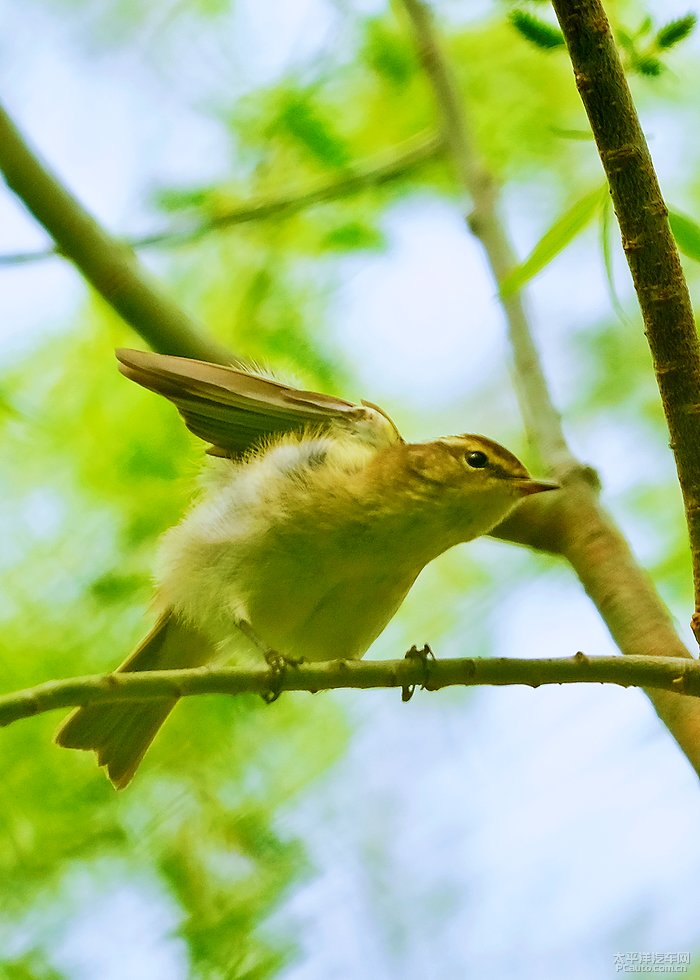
[0,136,444,267]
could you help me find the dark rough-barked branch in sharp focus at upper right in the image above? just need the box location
[553,0,700,643]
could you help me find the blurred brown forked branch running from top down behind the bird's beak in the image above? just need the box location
[403,0,700,775]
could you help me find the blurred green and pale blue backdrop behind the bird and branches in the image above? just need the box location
[0,0,700,980]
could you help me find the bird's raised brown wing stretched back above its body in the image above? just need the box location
[116,349,402,456]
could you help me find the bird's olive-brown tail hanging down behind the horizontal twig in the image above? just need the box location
[56,612,212,789]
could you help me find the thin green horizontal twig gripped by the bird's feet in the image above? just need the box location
[0,653,700,726]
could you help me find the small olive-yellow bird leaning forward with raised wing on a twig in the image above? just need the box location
[56,350,557,788]
